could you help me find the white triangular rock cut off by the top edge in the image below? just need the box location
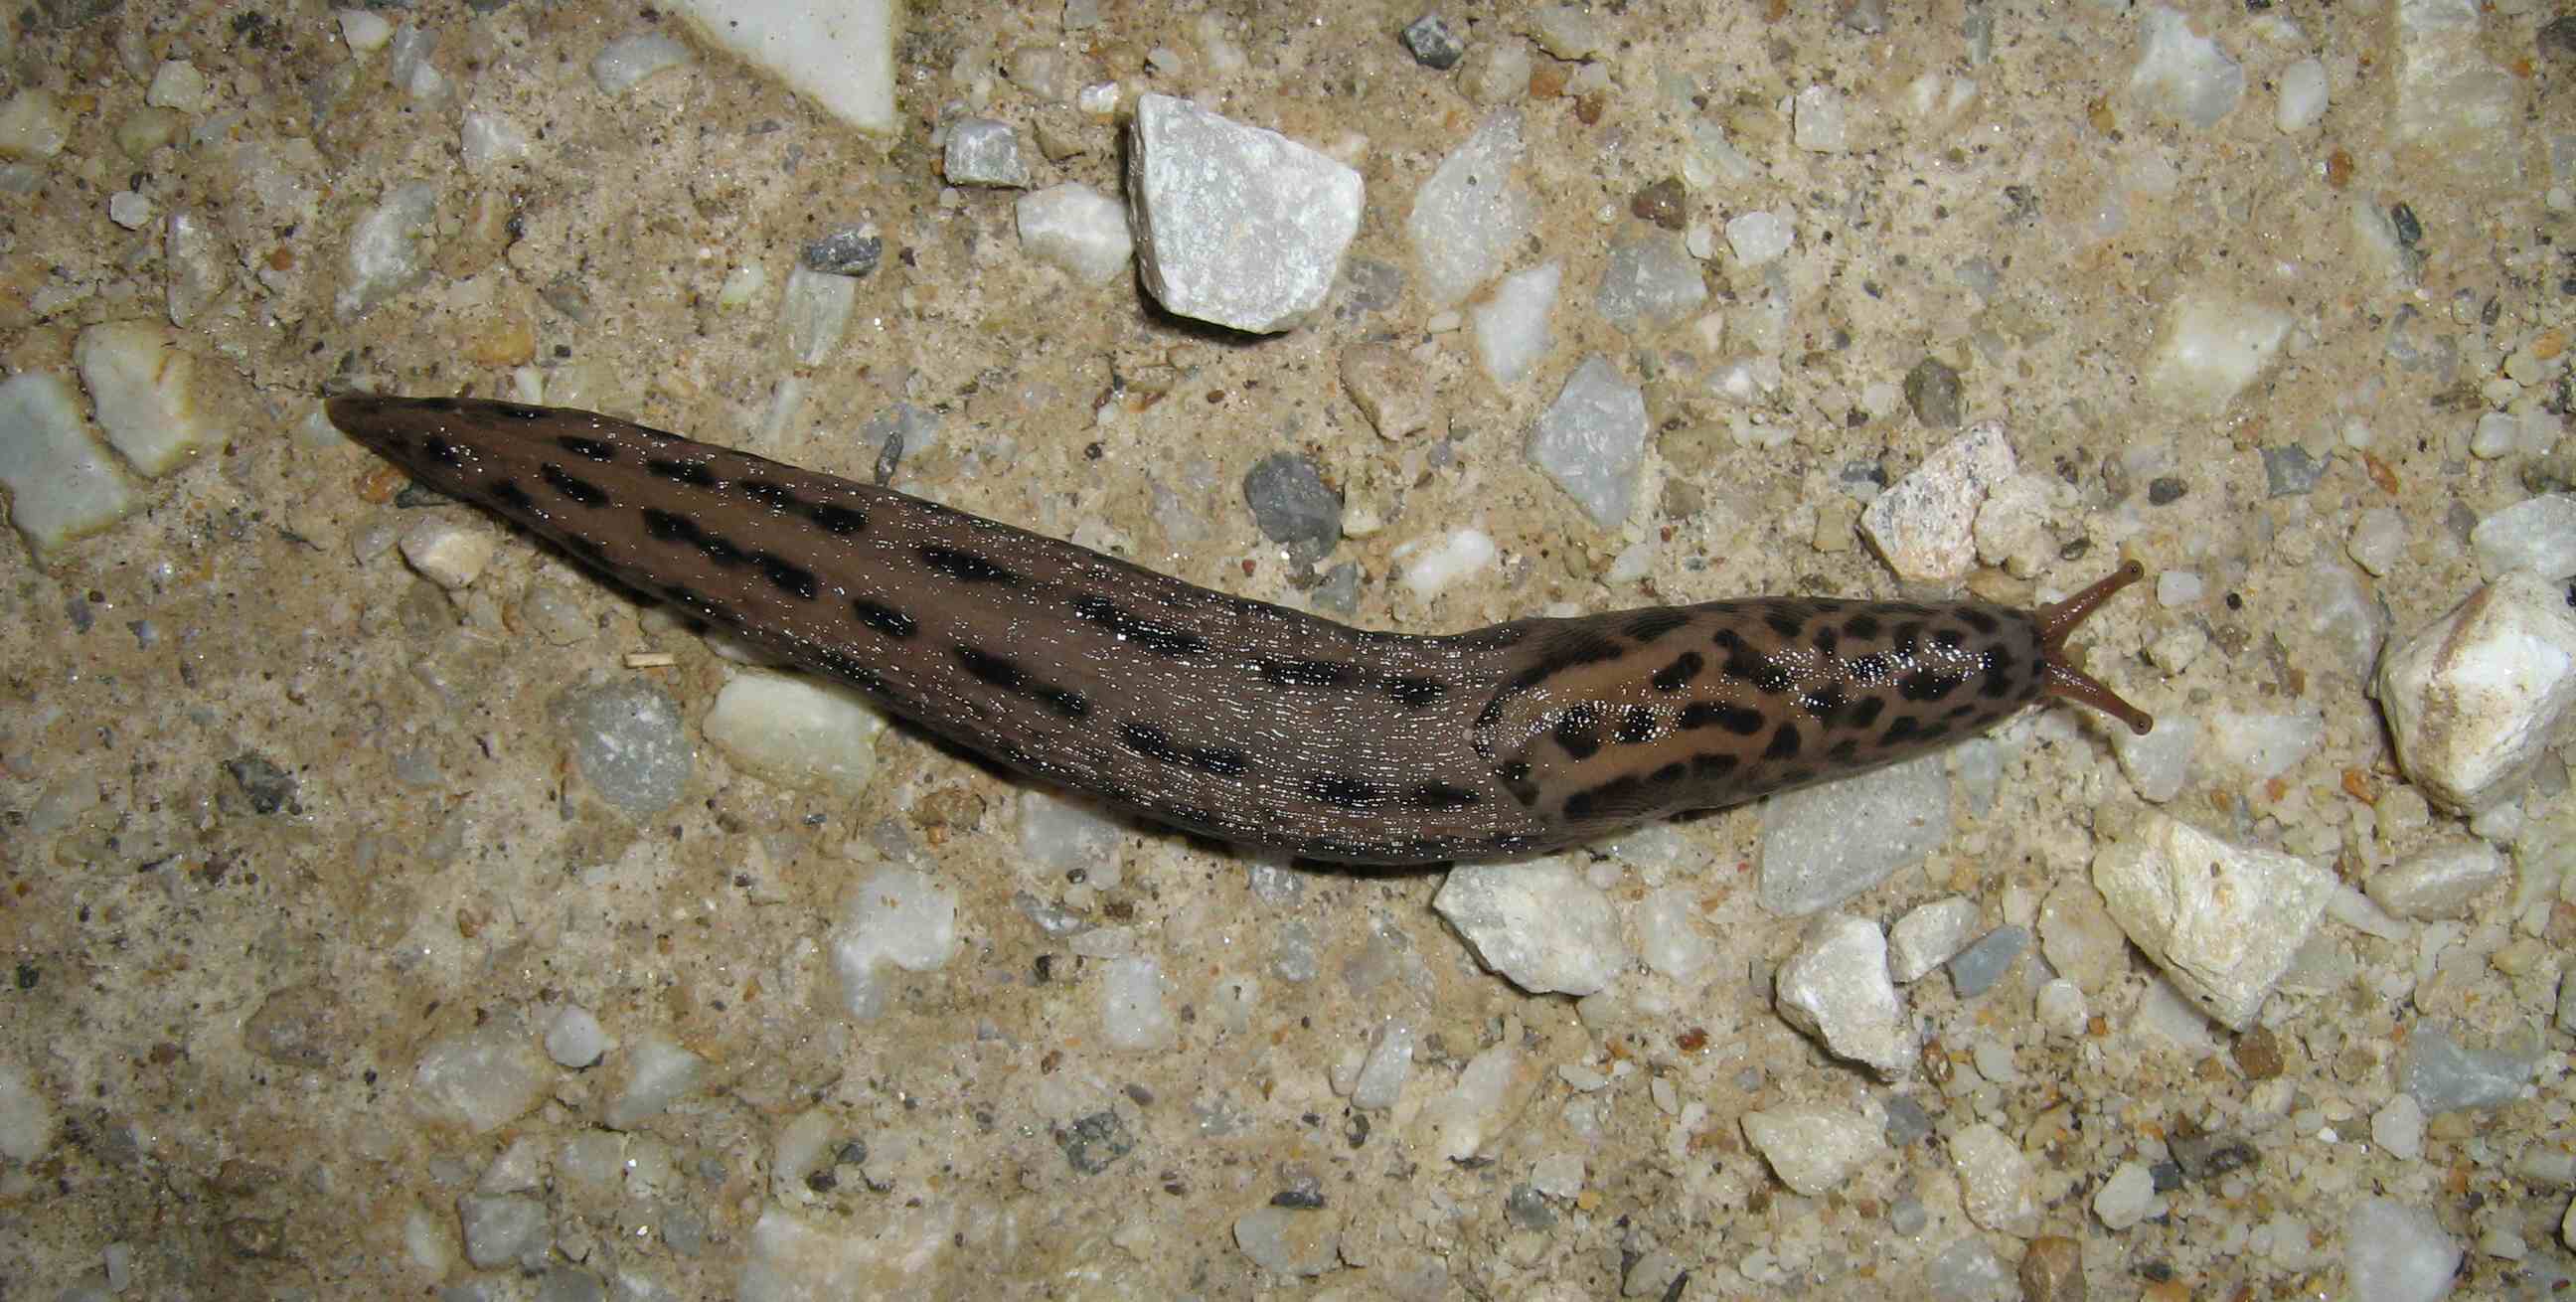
[675,0,901,136]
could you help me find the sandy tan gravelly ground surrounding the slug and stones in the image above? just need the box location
[0,0,2576,1299]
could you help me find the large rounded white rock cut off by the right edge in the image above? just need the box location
[2377,570,2576,812]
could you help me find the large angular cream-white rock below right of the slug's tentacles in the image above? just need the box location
[2092,815,2334,1032]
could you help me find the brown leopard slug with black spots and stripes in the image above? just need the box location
[327,395,2151,864]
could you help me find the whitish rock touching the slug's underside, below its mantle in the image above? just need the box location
[1432,859,1628,995]
